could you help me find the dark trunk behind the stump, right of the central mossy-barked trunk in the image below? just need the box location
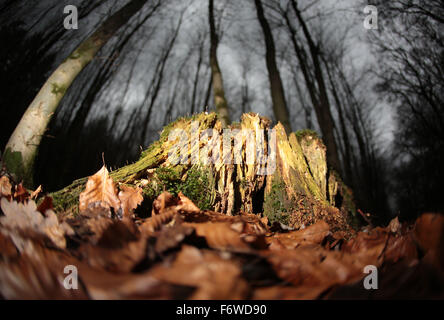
[255,0,291,133]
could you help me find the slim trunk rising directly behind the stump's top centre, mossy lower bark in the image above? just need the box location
[208,0,231,126]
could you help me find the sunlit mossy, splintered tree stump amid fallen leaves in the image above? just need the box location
[52,113,355,230]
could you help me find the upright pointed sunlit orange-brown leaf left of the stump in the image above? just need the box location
[79,166,120,212]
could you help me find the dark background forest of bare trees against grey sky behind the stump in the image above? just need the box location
[0,0,444,223]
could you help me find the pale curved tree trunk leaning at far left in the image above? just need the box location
[4,0,153,185]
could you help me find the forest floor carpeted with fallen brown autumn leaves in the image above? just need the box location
[0,168,444,299]
